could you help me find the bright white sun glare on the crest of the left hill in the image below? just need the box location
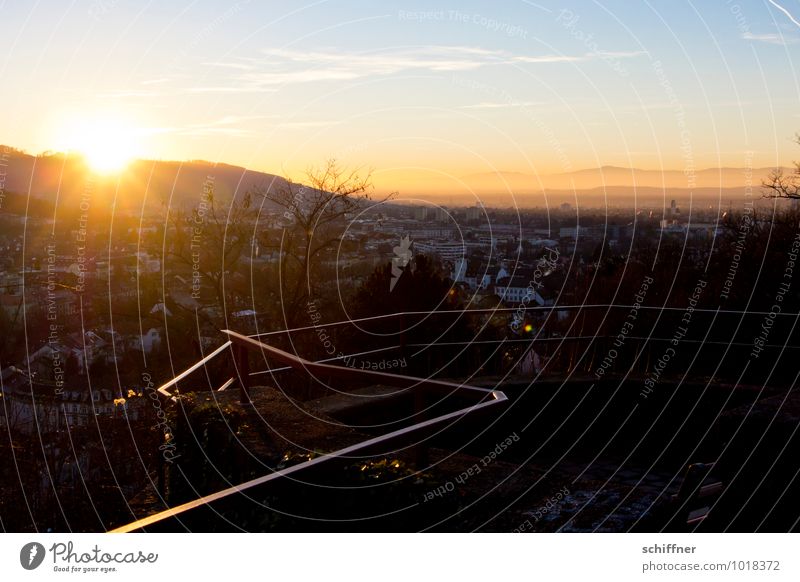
[59,118,136,174]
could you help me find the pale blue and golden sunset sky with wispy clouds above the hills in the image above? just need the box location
[0,0,800,190]
